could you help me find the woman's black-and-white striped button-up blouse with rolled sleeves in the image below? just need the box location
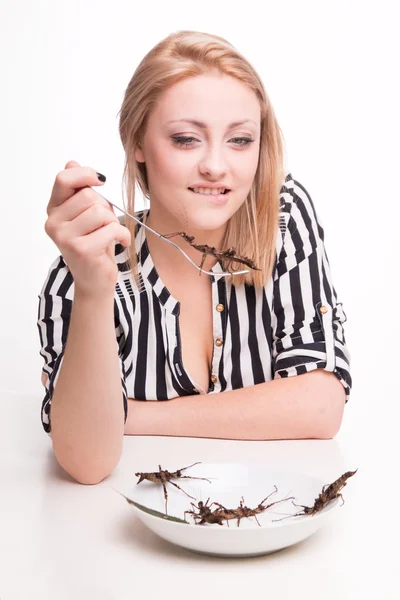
[37,173,352,436]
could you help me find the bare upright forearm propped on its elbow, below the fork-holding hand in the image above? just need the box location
[51,292,124,483]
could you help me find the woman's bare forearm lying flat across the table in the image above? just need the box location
[125,369,345,440]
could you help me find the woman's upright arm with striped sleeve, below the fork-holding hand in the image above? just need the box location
[38,267,127,484]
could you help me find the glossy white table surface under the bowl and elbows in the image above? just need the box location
[0,393,394,600]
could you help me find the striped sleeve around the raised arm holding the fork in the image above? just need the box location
[37,259,128,437]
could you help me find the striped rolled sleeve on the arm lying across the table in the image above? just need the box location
[272,180,352,402]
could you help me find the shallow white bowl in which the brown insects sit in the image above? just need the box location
[118,463,340,557]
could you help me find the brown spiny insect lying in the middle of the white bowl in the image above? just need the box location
[185,485,294,527]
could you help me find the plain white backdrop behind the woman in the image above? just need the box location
[0,0,400,478]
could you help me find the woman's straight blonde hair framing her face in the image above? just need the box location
[118,31,285,286]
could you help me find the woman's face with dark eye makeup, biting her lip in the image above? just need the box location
[135,73,260,235]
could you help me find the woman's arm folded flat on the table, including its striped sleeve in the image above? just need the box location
[125,177,352,439]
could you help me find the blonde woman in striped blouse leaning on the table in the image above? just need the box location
[38,31,351,483]
